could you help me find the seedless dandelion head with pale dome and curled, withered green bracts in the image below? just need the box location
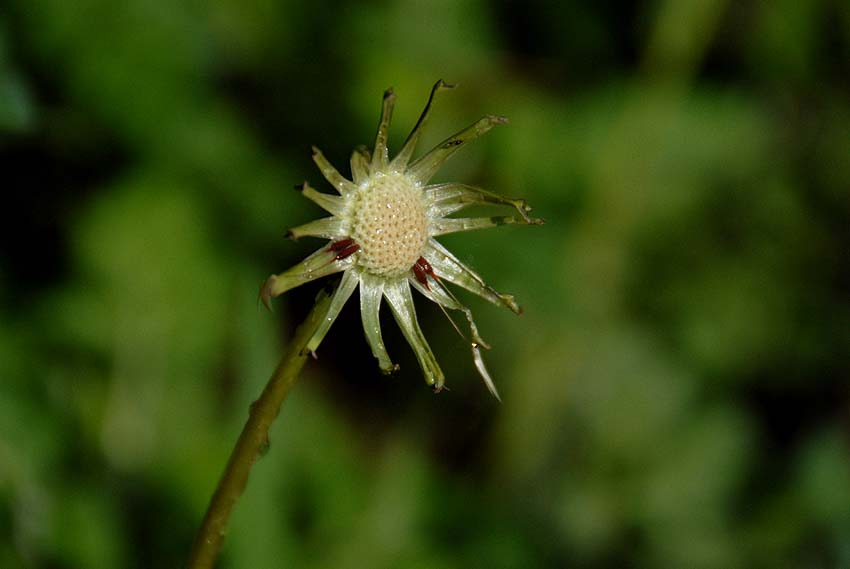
[260,81,542,398]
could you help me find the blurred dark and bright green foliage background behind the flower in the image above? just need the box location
[0,0,850,569]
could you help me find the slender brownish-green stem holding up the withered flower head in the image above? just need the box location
[188,292,331,569]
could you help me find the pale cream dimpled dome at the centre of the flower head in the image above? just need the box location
[351,173,428,276]
